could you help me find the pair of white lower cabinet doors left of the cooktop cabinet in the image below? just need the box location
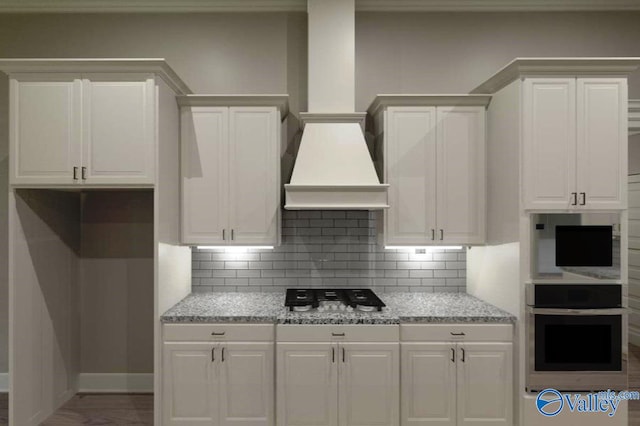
[163,324,275,426]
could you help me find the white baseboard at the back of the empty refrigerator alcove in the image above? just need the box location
[78,373,153,393]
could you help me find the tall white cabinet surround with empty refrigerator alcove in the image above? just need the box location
[0,59,191,426]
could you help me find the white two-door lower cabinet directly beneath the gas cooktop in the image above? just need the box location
[276,326,400,426]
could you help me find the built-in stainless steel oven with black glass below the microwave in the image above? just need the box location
[527,284,627,391]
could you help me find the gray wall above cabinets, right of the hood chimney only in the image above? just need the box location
[356,12,640,111]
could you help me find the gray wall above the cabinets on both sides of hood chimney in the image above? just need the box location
[0,12,640,372]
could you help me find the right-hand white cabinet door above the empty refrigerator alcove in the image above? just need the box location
[82,74,156,185]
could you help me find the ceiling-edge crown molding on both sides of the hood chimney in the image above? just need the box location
[0,0,640,13]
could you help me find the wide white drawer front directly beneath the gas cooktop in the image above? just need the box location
[276,324,400,342]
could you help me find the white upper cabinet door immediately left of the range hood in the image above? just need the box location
[229,107,280,245]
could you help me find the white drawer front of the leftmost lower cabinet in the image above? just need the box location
[164,324,275,342]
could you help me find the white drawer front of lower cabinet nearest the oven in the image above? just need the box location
[400,324,513,342]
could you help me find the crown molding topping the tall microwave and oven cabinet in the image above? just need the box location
[471,57,640,94]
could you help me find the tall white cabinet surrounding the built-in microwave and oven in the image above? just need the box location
[467,58,640,425]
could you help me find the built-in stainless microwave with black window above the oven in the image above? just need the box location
[532,213,620,280]
